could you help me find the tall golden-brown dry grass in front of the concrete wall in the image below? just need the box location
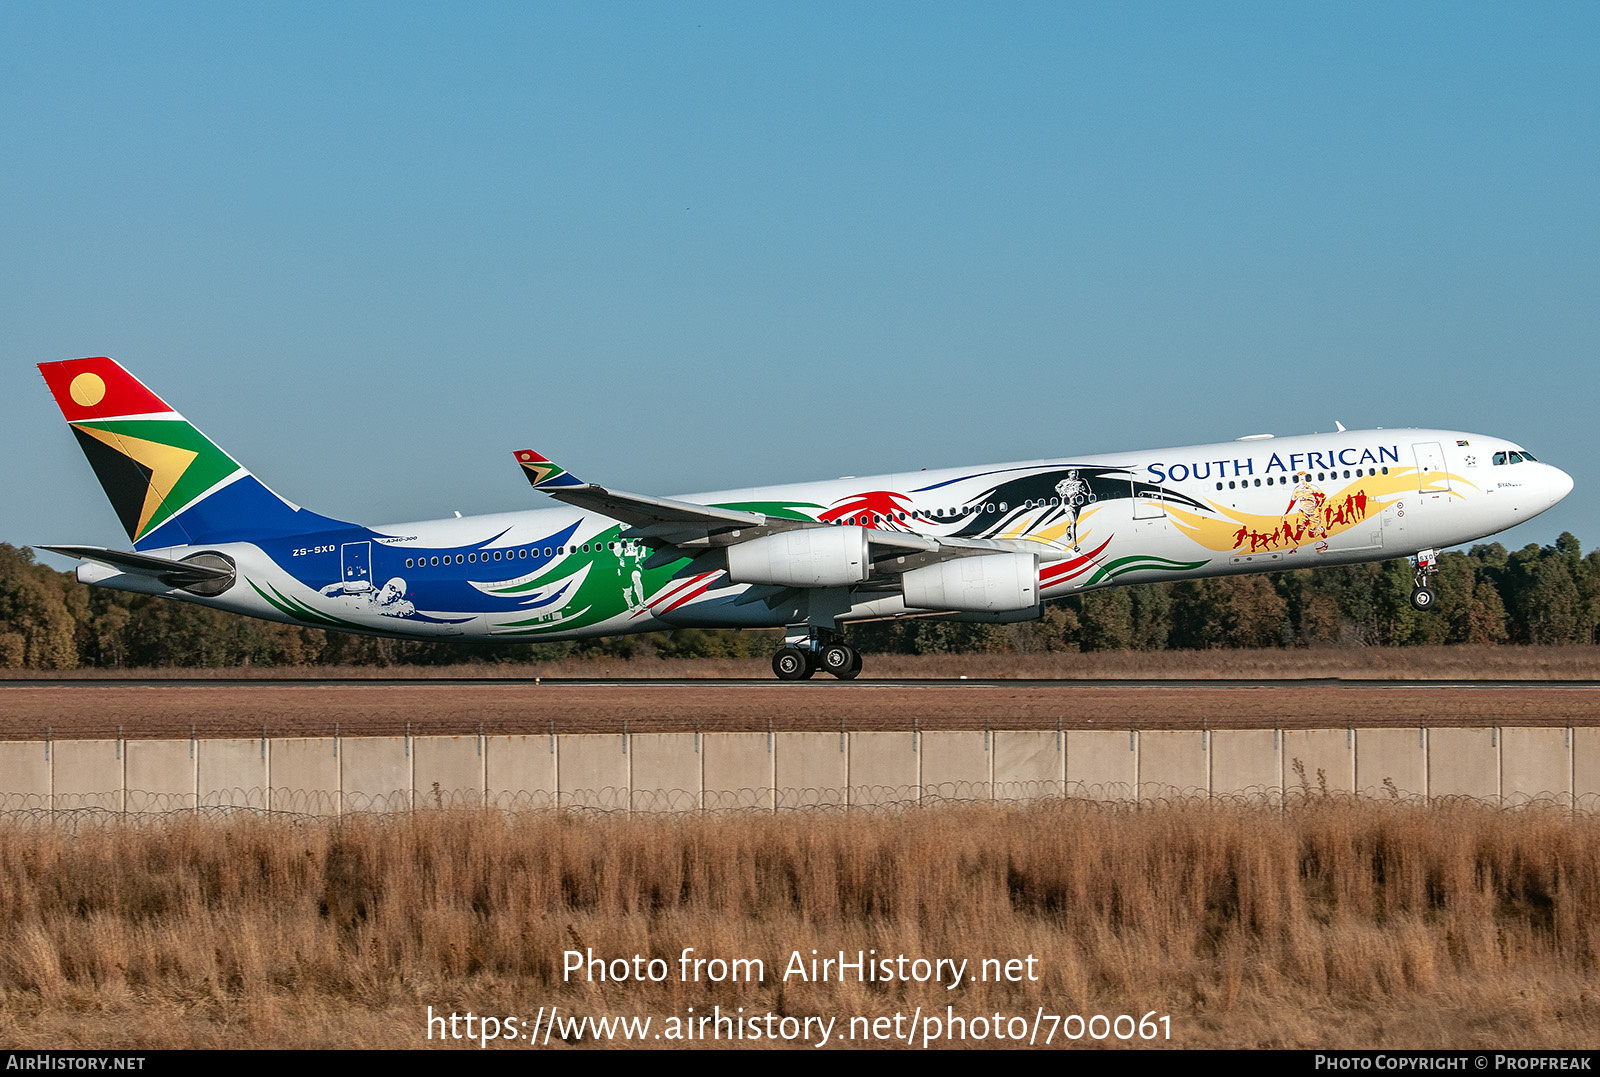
[0,799,1600,1048]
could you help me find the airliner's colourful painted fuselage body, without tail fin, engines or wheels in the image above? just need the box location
[78,429,1571,642]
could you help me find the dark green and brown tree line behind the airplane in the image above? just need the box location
[0,533,1600,669]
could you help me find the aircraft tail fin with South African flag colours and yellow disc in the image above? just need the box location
[38,357,349,551]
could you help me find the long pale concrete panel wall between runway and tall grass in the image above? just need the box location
[0,727,1600,815]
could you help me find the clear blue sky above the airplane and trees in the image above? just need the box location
[0,3,1600,567]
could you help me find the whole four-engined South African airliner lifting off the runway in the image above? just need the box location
[40,358,1573,680]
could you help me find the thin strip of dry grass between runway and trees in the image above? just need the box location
[9,645,1600,680]
